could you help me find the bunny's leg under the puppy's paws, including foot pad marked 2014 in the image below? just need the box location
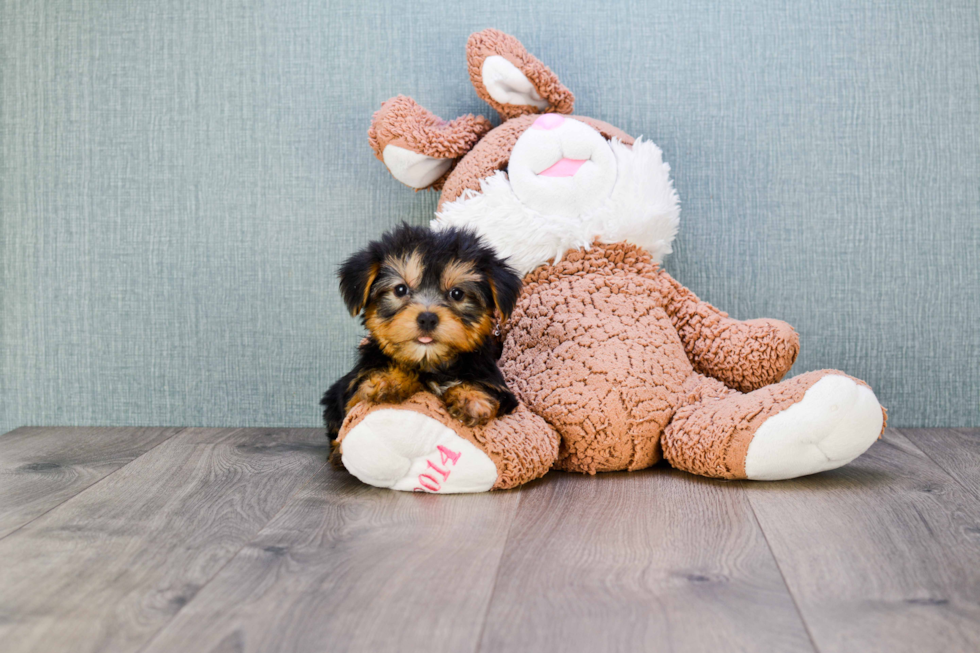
[337,392,558,494]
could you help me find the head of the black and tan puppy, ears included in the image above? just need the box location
[341,227,520,368]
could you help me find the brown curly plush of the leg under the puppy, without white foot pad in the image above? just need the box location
[338,392,559,490]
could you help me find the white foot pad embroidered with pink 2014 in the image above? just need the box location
[341,409,497,494]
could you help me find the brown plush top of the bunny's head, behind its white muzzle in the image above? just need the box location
[438,115,633,210]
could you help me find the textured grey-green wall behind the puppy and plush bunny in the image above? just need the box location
[0,0,980,432]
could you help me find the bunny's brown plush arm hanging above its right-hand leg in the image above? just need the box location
[655,270,800,392]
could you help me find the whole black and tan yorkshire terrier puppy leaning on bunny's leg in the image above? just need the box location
[320,225,521,450]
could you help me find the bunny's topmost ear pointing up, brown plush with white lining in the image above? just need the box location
[466,29,575,120]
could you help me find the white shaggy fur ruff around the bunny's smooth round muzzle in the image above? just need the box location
[432,139,680,276]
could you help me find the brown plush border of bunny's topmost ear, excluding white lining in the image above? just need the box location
[466,29,575,120]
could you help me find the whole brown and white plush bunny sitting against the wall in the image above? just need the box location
[339,30,885,493]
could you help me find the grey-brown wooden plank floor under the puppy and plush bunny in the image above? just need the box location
[0,428,980,653]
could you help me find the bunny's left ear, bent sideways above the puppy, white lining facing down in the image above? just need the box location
[368,95,492,190]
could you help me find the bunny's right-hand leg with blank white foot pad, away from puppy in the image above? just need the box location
[663,370,885,480]
